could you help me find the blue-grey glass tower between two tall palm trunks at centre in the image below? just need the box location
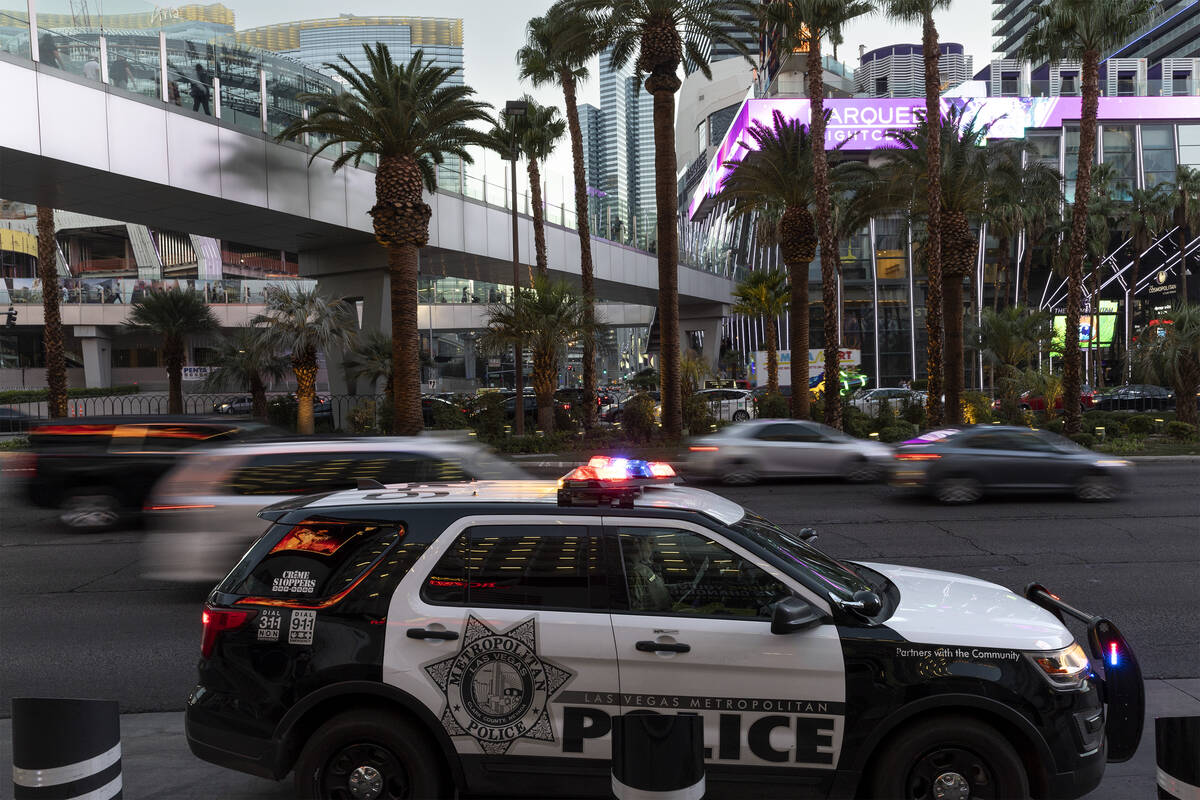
[581,49,655,246]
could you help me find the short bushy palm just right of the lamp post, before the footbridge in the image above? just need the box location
[479,276,590,433]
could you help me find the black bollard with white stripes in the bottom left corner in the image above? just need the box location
[12,697,121,800]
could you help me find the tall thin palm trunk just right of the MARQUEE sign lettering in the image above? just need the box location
[921,13,940,426]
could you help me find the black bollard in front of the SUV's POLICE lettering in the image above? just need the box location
[612,711,704,800]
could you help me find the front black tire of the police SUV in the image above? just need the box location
[866,715,1030,800]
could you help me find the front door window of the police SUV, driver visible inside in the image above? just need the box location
[618,528,792,619]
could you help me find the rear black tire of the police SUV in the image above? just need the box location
[295,709,450,800]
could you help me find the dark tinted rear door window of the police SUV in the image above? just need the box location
[421,525,599,610]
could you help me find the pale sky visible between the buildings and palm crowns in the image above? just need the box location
[221,0,992,176]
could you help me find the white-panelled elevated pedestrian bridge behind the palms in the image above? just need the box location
[0,54,731,314]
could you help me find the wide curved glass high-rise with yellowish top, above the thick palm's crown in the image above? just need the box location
[238,14,462,84]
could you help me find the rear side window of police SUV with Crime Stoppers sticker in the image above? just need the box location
[220,519,404,607]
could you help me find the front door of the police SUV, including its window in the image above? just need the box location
[605,517,846,796]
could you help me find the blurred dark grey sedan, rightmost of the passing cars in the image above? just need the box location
[892,425,1133,504]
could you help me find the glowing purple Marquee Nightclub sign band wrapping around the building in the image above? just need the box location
[688,96,1200,217]
